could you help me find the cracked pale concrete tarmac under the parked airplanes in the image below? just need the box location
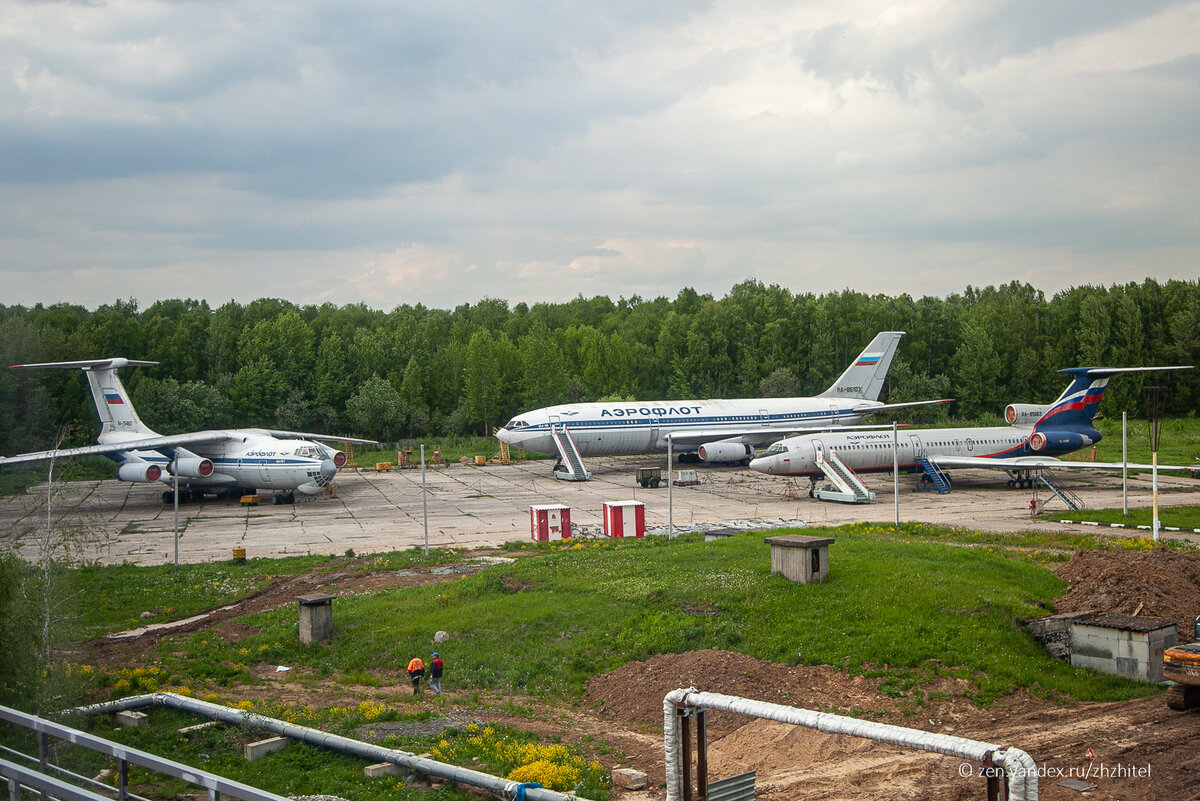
[0,457,1200,565]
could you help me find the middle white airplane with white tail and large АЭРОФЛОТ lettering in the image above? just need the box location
[496,331,946,480]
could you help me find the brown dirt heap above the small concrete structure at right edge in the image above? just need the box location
[1055,548,1200,643]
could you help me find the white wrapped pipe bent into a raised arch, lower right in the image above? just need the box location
[662,687,1038,801]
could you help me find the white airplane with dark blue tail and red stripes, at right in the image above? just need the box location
[750,367,1190,488]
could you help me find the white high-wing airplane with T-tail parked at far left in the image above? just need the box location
[0,359,376,504]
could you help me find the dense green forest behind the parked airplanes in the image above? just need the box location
[0,275,1200,454]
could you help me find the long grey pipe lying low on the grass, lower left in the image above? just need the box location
[68,693,587,801]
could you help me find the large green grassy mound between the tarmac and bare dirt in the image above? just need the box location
[129,526,1157,704]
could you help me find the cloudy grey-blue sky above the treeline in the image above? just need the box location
[0,0,1200,309]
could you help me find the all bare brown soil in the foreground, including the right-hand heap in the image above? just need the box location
[82,549,1200,801]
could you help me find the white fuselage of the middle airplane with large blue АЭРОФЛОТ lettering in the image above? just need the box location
[497,397,883,456]
